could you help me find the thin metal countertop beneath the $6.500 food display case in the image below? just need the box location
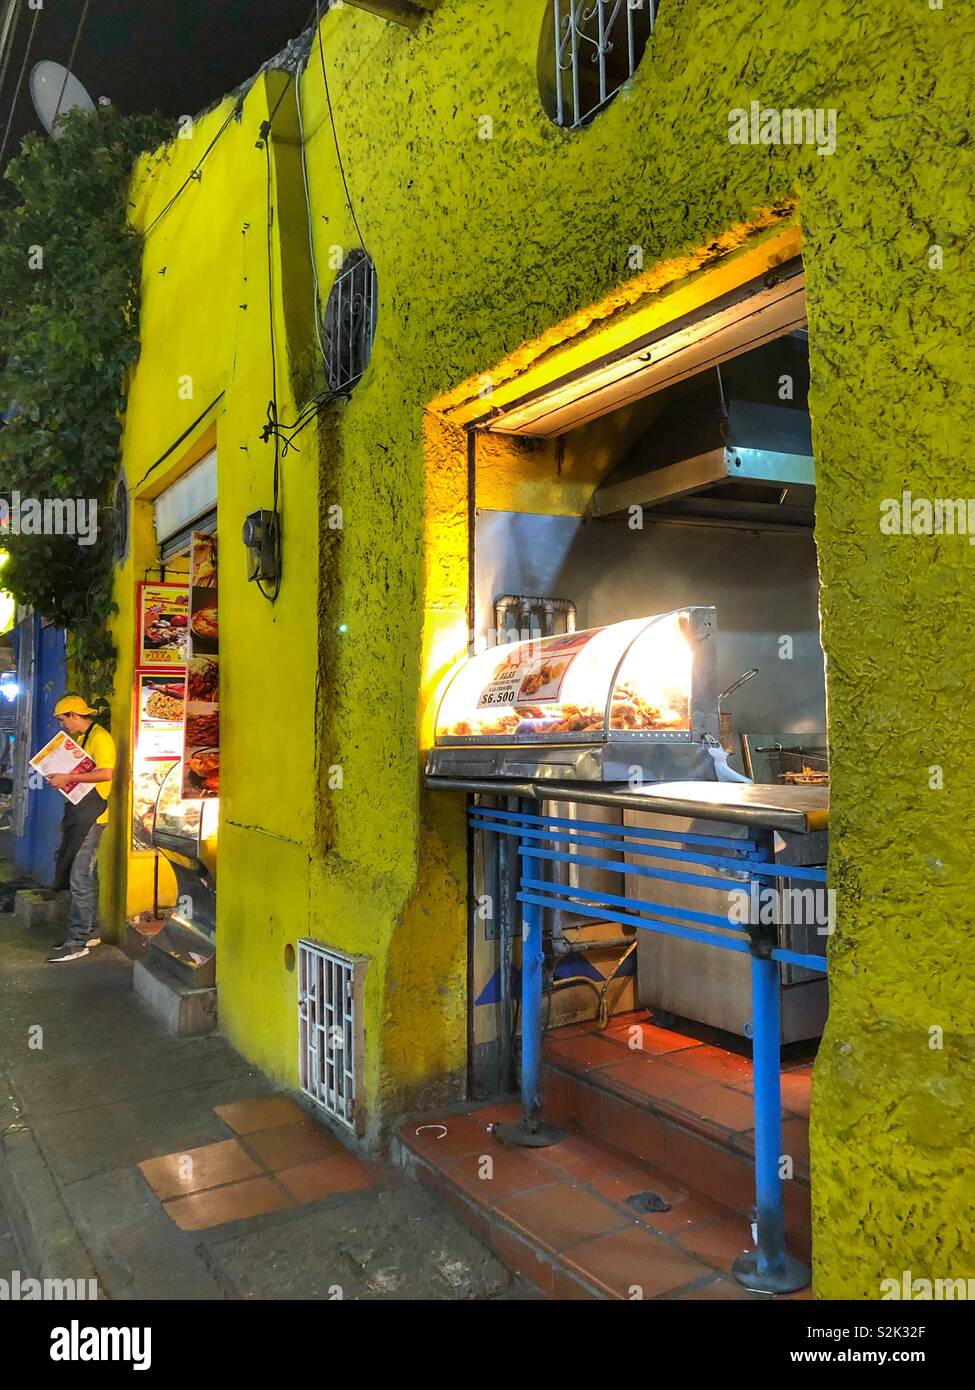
[426,777,829,834]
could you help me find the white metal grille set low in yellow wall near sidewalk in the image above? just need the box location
[298,941,366,1133]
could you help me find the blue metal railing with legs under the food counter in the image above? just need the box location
[470,806,826,1293]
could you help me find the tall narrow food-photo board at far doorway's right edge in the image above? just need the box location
[182,531,220,801]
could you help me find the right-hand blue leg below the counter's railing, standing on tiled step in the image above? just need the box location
[751,956,786,1275]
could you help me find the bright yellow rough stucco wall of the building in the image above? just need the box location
[107,0,975,1298]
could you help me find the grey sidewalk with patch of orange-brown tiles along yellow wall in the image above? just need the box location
[0,915,538,1301]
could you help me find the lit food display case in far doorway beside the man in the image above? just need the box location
[152,763,220,988]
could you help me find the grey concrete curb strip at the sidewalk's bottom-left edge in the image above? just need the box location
[0,1076,104,1295]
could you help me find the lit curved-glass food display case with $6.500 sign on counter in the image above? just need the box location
[427,607,718,783]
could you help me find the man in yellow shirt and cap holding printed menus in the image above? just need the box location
[47,695,115,960]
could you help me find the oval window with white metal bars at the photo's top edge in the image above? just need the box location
[552,0,658,129]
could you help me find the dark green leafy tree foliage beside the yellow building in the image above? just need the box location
[0,107,171,694]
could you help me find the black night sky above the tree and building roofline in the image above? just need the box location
[0,0,314,163]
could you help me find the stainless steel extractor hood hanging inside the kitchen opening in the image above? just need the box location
[593,328,815,525]
